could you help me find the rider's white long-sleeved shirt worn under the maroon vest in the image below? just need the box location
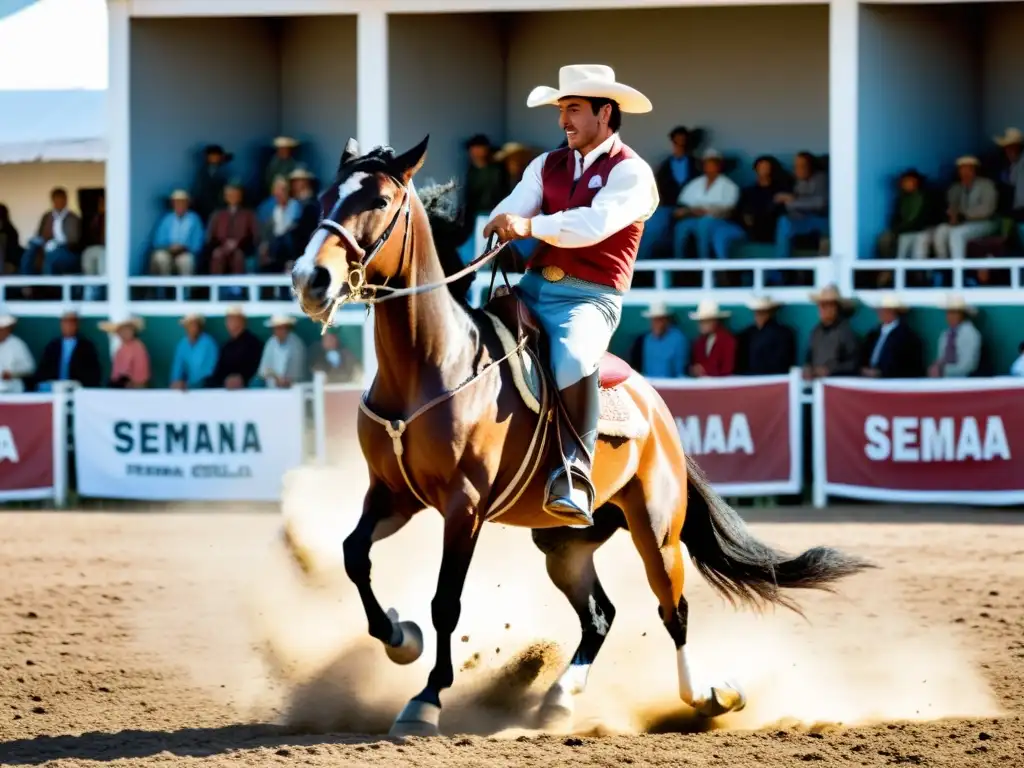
[490,134,658,248]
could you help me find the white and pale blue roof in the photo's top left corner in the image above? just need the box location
[0,0,108,163]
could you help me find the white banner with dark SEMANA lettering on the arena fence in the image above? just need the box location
[75,387,305,501]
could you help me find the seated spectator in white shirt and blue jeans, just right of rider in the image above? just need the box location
[672,150,739,259]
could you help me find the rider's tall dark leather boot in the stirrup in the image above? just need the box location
[544,371,600,527]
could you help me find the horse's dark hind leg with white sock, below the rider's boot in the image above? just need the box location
[534,505,626,727]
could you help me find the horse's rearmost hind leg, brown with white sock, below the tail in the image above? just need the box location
[626,481,745,717]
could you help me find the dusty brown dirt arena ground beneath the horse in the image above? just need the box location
[0,473,1024,768]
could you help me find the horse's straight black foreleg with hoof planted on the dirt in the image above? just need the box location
[391,495,482,736]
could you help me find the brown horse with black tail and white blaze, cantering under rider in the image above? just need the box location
[286,139,870,734]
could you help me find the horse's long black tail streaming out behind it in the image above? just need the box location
[683,455,874,613]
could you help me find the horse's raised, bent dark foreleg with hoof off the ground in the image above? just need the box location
[344,480,423,664]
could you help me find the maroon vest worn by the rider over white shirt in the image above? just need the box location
[528,136,643,292]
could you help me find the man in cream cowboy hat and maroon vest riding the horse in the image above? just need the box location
[483,65,658,526]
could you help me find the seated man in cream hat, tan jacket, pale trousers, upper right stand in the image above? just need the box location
[921,156,999,261]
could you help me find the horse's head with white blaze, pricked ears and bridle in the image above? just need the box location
[292,137,429,322]
